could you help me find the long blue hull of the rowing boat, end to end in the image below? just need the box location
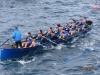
[0,22,93,61]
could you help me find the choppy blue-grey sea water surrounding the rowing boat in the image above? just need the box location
[0,0,100,75]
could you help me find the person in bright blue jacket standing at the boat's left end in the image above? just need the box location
[11,27,22,48]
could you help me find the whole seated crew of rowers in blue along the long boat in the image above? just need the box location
[22,17,87,48]
